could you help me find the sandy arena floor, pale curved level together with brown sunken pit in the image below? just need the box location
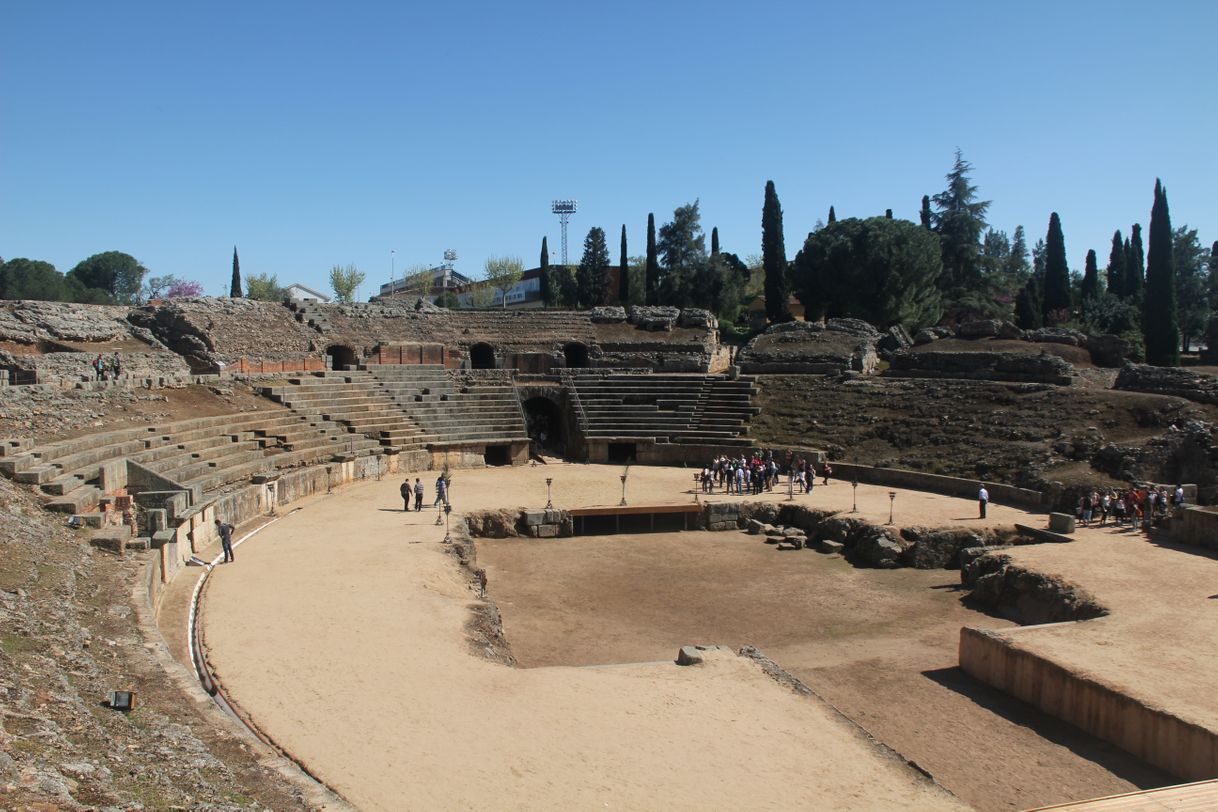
[203,465,1188,810]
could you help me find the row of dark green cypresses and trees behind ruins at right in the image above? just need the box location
[540,150,1218,365]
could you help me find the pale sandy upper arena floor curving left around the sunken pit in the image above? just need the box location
[203,466,964,810]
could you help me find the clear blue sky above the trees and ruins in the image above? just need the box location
[0,0,1218,297]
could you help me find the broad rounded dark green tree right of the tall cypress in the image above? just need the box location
[792,217,943,329]
